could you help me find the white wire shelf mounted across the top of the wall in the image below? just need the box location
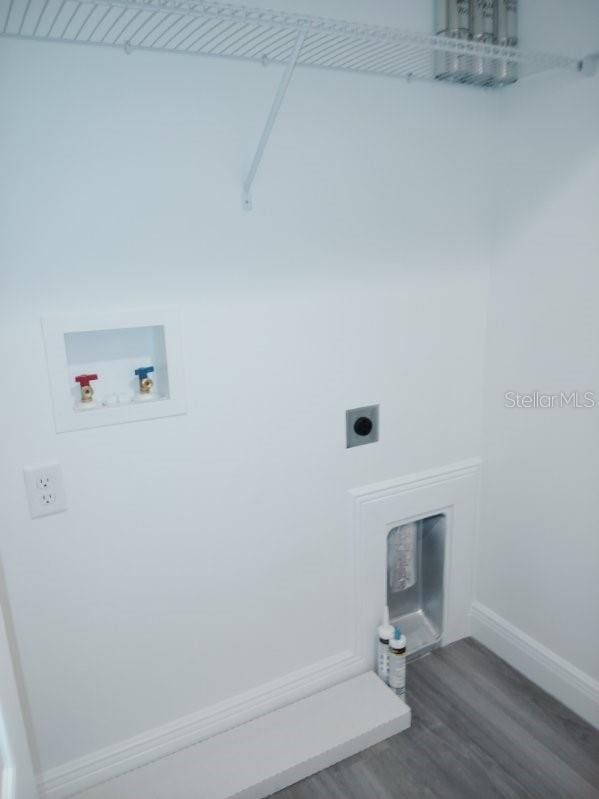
[0,0,581,86]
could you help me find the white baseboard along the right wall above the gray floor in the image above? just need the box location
[470,602,599,728]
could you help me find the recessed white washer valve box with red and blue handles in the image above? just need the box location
[44,312,185,431]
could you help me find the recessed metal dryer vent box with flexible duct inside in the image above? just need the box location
[387,514,447,658]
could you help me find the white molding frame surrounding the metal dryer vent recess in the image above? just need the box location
[350,458,482,668]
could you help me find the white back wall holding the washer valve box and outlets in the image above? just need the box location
[0,3,494,769]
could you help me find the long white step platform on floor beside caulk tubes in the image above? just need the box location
[77,672,411,799]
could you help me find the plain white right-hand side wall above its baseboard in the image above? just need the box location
[477,2,599,679]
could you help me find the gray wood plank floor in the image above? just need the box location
[272,638,599,799]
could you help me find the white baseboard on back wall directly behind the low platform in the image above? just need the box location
[40,652,367,799]
